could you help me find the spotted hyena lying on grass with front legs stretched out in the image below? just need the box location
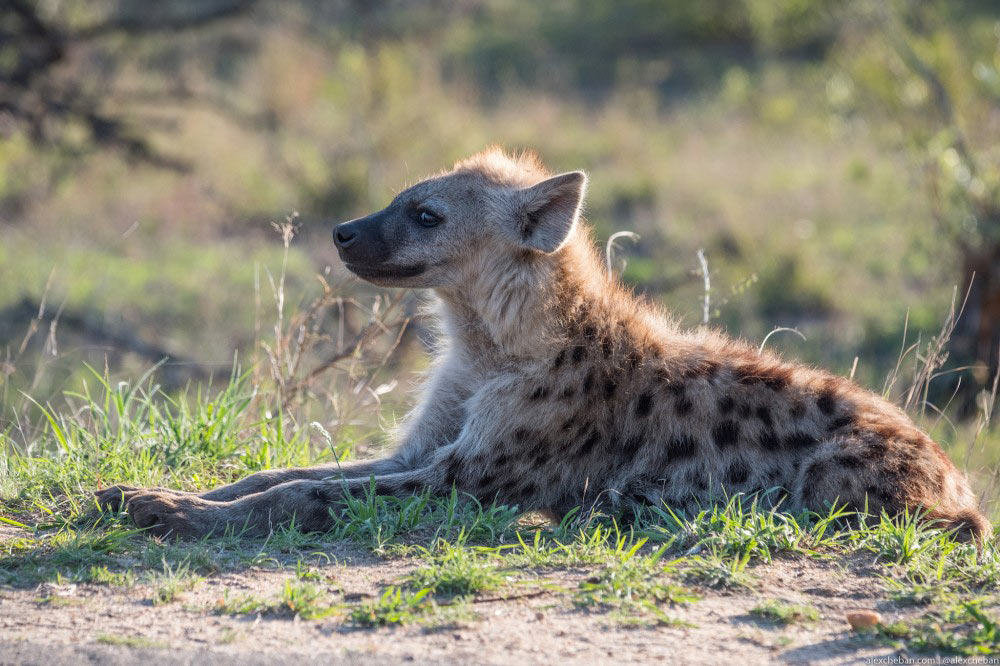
[98,150,990,539]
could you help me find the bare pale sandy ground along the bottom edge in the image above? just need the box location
[0,524,913,666]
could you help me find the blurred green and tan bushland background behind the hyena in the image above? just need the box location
[0,0,1000,423]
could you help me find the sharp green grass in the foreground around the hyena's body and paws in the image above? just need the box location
[0,368,1000,654]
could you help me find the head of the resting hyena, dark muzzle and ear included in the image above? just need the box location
[333,149,587,287]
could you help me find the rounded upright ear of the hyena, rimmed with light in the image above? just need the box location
[517,171,587,253]
